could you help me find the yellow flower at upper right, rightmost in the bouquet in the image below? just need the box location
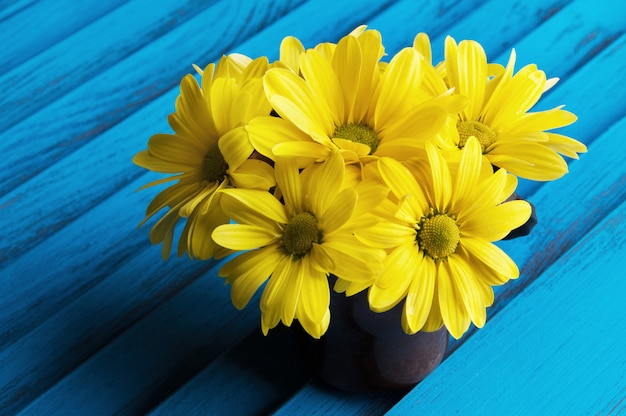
[414,34,587,181]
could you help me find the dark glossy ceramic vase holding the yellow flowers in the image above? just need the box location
[300,280,448,392]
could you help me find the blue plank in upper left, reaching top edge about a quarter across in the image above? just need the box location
[0,0,221,128]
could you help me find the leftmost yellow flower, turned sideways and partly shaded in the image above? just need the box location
[133,54,274,259]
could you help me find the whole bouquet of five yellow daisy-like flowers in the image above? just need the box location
[133,26,586,338]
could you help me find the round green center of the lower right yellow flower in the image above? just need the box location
[416,210,461,260]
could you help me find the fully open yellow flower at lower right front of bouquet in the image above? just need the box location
[356,137,531,338]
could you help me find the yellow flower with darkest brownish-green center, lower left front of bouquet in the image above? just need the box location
[213,153,384,338]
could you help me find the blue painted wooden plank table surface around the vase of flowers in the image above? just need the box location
[0,0,626,415]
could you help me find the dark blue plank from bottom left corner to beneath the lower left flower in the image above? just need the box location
[14,258,260,415]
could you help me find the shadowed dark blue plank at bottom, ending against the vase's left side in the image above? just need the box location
[150,326,310,416]
